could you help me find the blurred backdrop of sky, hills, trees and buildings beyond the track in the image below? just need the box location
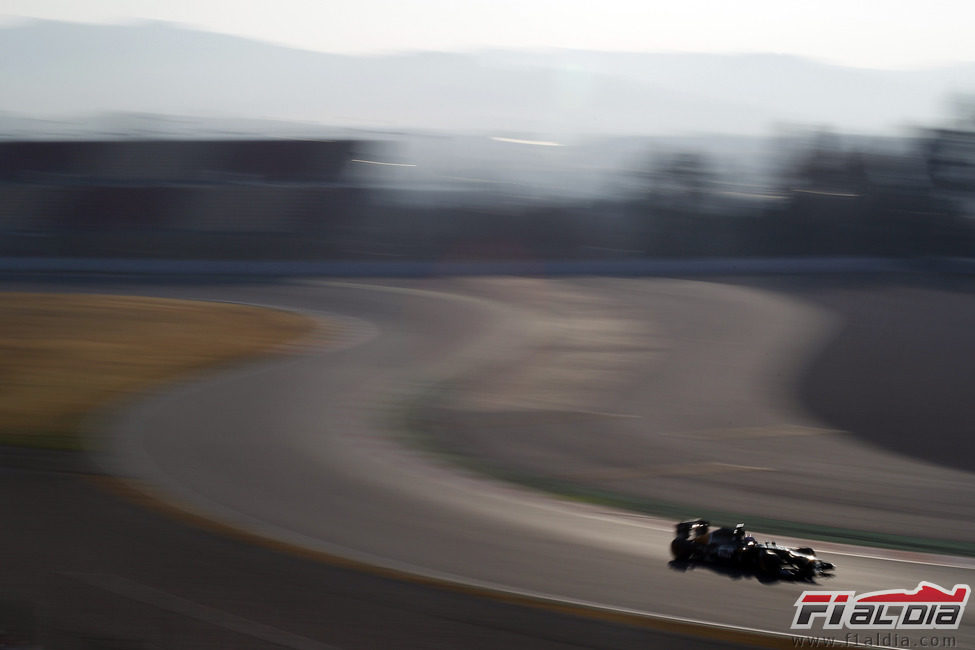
[0,0,975,261]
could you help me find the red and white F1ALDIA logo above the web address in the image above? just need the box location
[792,581,972,630]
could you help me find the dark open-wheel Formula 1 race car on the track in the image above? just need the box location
[670,519,834,580]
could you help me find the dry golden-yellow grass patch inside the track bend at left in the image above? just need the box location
[0,293,316,448]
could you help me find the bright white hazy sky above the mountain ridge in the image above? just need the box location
[0,0,975,67]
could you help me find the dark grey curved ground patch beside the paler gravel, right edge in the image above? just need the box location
[800,278,975,471]
